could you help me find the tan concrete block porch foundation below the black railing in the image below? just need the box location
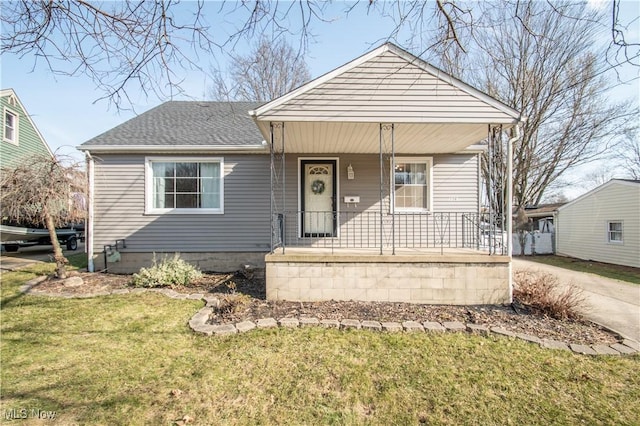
[265,249,511,305]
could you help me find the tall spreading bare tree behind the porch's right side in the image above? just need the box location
[432,0,638,206]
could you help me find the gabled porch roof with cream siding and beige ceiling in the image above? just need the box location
[250,43,521,154]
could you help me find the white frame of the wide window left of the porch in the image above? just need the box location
[144,157,225,215]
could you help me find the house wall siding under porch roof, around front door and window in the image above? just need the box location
[278,154,479,247]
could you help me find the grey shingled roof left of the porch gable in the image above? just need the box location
[79,101,263,151]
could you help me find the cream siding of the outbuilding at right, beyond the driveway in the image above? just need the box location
[556,181,640,267]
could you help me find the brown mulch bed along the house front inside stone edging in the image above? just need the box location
[28,272,619,345]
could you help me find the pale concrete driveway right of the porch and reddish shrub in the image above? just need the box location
[513,258,640,342]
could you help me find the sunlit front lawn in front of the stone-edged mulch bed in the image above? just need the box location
[0,264,640,425]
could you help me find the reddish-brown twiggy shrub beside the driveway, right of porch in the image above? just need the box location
[513,271,585,319]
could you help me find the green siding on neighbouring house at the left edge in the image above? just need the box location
[0,94,51,167]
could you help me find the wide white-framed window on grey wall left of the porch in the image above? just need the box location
[147,158,223,213]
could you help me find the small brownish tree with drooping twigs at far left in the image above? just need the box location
[0,156,86,278]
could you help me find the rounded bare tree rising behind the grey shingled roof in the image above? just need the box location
[210,38,311,101]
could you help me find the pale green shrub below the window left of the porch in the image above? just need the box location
[131,253,202,287]
